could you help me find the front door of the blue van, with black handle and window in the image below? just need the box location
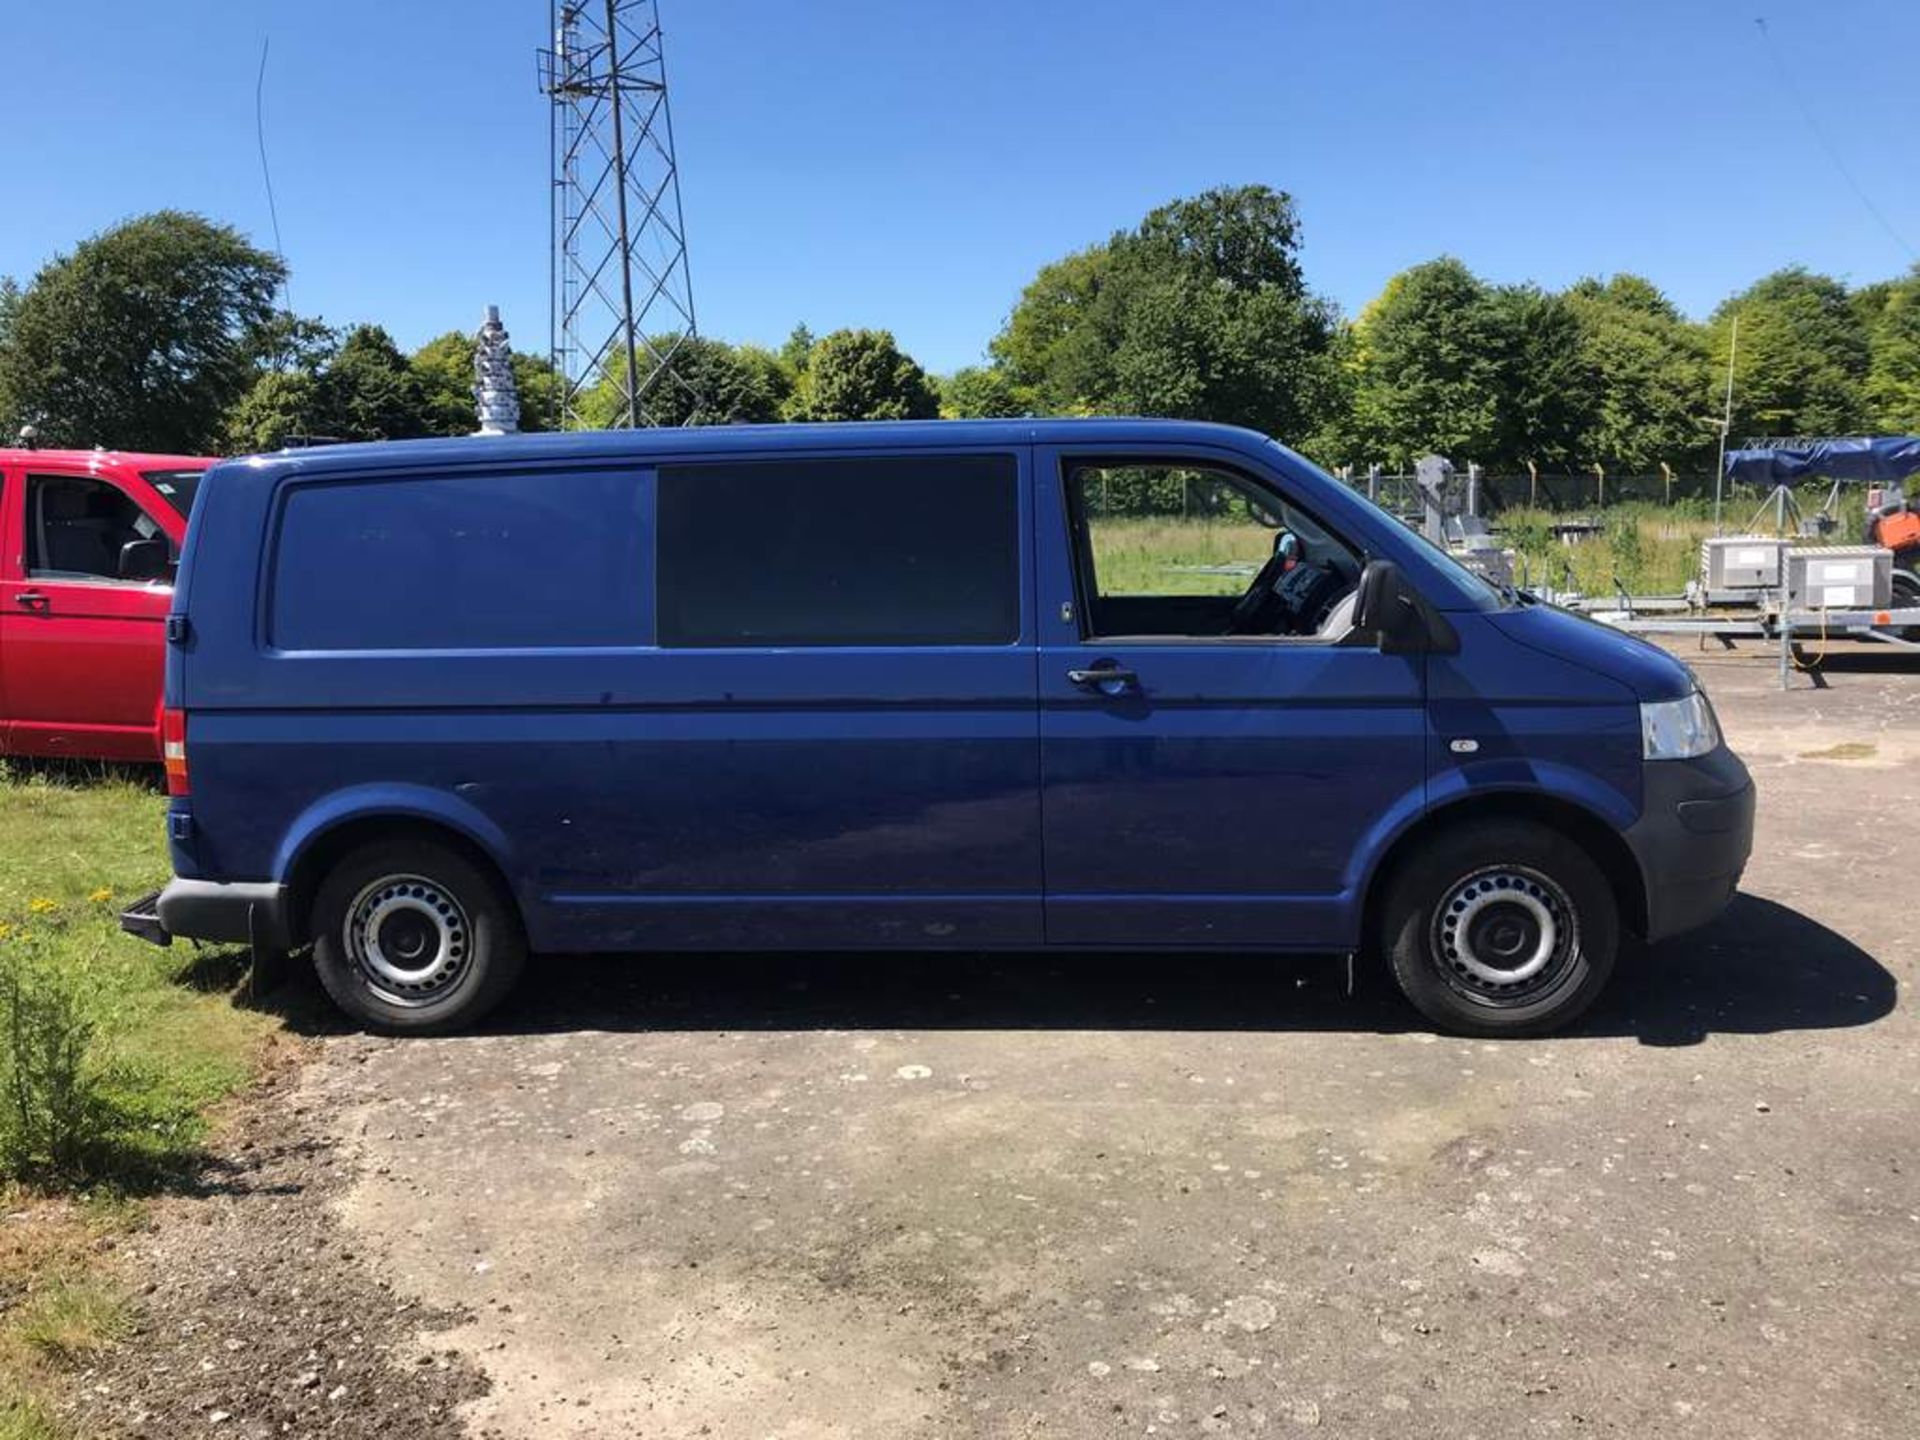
[1035,447,1425,950]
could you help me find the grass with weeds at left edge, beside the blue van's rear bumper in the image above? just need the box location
[0,762,273,1440]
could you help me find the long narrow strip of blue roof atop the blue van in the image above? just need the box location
[223,417,1265,481]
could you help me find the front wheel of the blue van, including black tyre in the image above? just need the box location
[1380,820,1620,1037]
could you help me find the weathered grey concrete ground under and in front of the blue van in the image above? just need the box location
[301,651,1920,1440]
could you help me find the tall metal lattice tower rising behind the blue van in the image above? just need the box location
[540,0,697,428]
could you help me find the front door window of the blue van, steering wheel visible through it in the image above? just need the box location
[1066,459,1361,639]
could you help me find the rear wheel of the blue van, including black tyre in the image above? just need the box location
[313,839,526,1035]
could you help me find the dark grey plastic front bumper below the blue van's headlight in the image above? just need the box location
[1626,745,1755,941]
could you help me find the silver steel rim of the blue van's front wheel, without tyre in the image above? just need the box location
[1432,866,1580,1006]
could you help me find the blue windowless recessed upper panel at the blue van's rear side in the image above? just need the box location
[269,470,649,651]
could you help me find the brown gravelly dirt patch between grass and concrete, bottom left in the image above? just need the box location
[63,1044,486,1440]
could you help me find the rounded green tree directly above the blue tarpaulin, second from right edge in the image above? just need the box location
[1707,265,1868,442]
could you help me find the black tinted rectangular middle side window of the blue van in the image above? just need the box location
[657,455,1020,647]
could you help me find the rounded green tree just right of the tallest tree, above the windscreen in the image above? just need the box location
[1354,257,1511,467]
